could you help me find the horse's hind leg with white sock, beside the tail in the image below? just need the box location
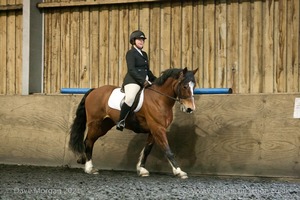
[84,118,115,174]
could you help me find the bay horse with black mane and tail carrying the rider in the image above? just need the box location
[69,68,198,179]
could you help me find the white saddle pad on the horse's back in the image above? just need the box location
[108,88,144,112]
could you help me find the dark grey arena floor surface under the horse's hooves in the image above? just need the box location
[0,165,300,200]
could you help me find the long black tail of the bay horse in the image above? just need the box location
[69,89,94,154]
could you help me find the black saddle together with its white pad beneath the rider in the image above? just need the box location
[108,88,144,112]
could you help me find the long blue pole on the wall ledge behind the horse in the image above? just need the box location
[60,88,232,94]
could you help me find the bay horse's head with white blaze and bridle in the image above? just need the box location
[176,68,198,113]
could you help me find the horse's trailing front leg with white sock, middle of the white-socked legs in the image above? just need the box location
[136,134,154,177]
